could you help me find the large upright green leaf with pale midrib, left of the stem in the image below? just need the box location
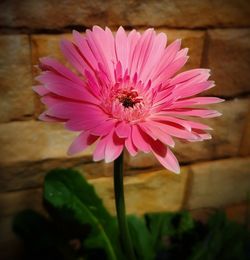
[44,169,123,260]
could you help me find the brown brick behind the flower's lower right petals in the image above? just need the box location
[127,99,249,168]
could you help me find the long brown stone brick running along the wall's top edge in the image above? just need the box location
[0,0,250,29]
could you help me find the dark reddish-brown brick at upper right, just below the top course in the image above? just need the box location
[204,29,250,96]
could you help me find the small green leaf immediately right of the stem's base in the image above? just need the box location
[127,216,155,260]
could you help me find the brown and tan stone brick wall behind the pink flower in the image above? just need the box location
[0,0,250,259]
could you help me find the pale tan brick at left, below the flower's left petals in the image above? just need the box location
[0,121,92,166]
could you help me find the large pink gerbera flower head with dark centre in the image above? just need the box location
[34,26,223,173]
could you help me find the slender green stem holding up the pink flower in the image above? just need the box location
[114,152,136,260]
